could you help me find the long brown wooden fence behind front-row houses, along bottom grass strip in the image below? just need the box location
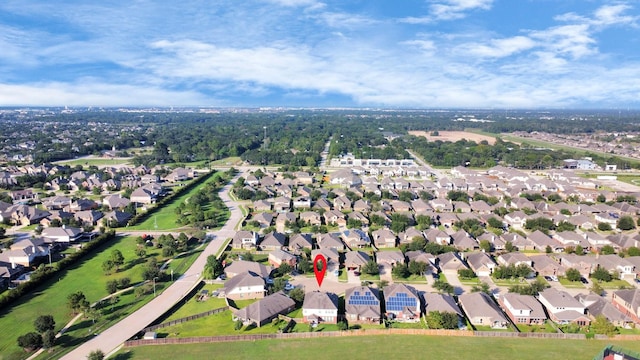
[124,329,586,347]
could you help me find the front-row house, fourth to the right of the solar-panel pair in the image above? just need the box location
[538,288,591,326]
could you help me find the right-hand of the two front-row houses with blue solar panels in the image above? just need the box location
[383,284,422,322]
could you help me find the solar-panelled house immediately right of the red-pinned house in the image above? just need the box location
[344,286,382,324]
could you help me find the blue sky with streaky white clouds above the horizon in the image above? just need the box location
[0,0,640,108]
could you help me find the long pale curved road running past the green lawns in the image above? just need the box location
[62,172,242,360]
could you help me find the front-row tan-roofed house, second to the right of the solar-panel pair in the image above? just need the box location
[458,292,509,329]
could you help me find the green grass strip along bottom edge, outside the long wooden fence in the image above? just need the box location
[115,335,640,360]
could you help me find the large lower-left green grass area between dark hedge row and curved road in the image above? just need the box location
[0,233,201,360]
